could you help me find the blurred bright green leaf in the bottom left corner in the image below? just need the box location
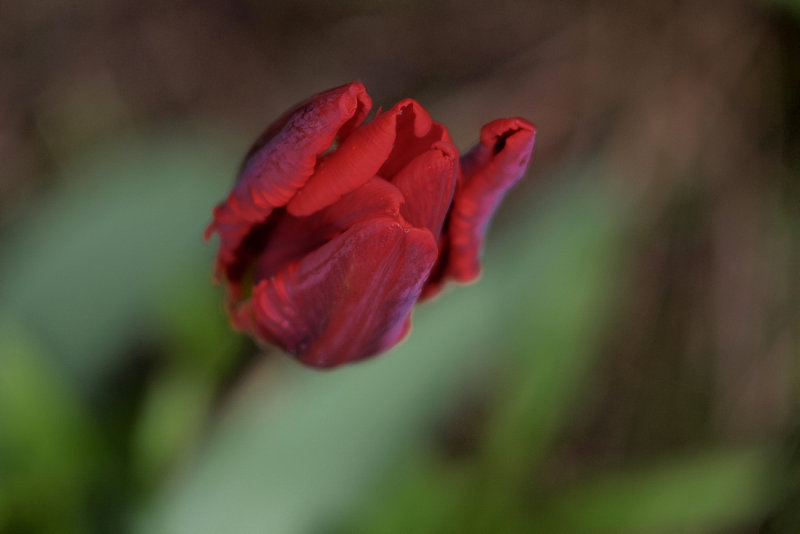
[0,313,96,533]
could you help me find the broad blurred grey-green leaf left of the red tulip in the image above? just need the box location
[0,132,235,385]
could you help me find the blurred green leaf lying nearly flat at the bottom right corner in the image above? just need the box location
[535,449,772,534]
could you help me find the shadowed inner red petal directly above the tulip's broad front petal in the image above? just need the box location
[255,177,404,282]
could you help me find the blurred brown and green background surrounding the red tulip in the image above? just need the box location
[0,0,800,534]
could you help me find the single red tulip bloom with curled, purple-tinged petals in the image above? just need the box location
[206,82,535,367]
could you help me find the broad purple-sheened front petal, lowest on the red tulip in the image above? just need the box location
[250,218,437,367]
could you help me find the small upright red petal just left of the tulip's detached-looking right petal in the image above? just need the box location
[392,141,458,240]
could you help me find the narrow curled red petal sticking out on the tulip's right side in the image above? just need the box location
[446,118,536,282]
